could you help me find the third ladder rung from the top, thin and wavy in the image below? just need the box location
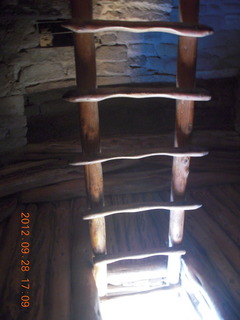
[70,147,208,166]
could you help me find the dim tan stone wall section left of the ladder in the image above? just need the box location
[0,0,72,152]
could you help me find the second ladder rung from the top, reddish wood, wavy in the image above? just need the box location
[63,87,211,103]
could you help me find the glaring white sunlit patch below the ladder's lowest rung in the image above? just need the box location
[101,262,220,320]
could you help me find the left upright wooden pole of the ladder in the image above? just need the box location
[71,0,107,295]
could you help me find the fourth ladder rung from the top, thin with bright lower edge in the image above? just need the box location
[83,201,202,220]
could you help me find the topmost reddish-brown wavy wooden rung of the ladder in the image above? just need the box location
[63,19,213,38]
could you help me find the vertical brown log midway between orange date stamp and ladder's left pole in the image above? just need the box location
[47,201,73,319]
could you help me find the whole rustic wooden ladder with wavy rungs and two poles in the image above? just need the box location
[64,0,213,296]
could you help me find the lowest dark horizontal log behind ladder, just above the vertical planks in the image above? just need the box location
[18,170,240,202]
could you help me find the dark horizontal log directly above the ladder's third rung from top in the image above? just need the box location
[0,130,240,166]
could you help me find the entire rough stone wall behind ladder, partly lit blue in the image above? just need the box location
[0,0,240,150]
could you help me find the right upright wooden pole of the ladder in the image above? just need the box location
[169,0,199,282]
